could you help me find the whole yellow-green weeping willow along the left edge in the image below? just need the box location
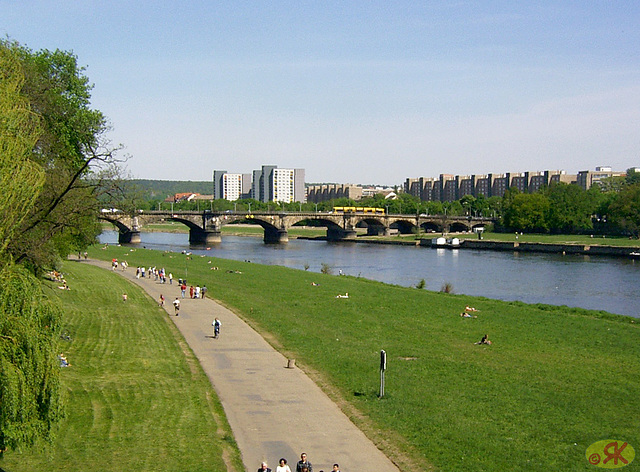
[0,42,61,456]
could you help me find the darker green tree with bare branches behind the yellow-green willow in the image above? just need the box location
[0,40,125,268]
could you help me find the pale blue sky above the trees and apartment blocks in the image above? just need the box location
[0,0,640,185]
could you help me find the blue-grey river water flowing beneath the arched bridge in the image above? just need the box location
[100,231,640,318]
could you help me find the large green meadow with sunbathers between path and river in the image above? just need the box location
[84,247,640,471]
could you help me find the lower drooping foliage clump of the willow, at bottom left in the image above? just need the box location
[0,266,62,455]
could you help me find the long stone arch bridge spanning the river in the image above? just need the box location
[100,210,493,244]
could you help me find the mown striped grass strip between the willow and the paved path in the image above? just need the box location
[0,262,243,472]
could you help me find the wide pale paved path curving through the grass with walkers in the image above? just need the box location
[85,260,399,472]
